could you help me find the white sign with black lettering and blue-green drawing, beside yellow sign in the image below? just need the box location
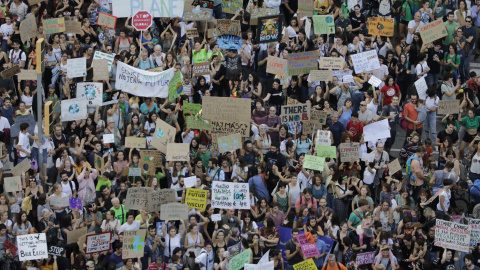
[212,181,250,209]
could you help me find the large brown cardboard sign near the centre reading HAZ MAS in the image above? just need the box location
[202,96,251,123]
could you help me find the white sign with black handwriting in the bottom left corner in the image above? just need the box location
[16,233,47,262]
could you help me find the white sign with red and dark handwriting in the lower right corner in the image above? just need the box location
[434,219,471,252]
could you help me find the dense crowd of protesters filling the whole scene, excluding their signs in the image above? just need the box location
[0,0,480,270]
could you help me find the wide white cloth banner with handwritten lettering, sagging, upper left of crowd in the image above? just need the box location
[115,61,175,98]
